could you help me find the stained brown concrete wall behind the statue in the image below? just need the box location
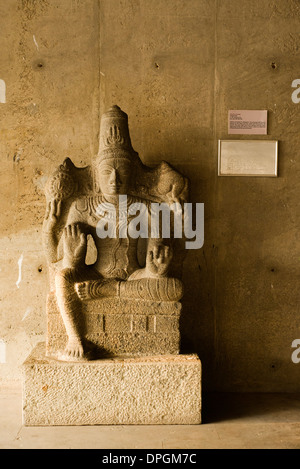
[0,0,300,391]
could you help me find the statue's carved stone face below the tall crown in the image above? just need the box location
[99,158,132,195]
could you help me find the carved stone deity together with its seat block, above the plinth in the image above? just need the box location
[43,106,188,361]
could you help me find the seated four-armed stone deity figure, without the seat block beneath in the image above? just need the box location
[43,106,187,360]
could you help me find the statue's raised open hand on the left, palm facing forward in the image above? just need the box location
[63,224,87,268]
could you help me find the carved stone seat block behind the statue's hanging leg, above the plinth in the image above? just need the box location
[47,293,182,357]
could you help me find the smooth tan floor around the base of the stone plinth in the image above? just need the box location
[0,386,300,449]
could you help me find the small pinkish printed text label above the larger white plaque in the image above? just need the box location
[228,110,268,135]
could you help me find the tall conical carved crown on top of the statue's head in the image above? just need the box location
[98,105,137,161]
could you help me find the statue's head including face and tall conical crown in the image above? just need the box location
[97,106,139,196]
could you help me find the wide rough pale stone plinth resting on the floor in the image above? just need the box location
[23,344,201,426]
